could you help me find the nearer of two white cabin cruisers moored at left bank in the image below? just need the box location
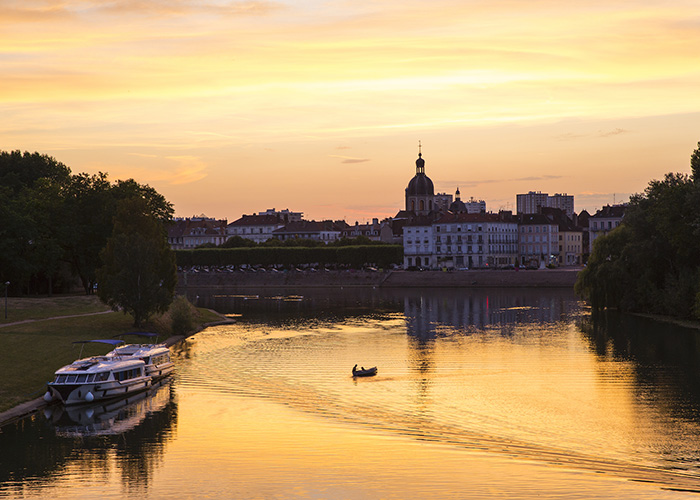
[44,356,152,405]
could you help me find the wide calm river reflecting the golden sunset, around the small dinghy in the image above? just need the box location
[0,289,700,499]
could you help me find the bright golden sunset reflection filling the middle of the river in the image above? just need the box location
[165,315,700,498]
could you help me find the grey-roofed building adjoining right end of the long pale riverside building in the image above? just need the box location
[518,213,559,268]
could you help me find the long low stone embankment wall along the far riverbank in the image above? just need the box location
[178,268,580,292]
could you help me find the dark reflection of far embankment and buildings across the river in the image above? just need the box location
[188,288,579,339]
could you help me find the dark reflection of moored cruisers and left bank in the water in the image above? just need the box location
[0,380,177,494]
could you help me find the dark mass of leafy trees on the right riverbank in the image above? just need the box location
[576,142,700,319]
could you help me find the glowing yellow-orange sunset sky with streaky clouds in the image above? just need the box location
[0,0,700,223]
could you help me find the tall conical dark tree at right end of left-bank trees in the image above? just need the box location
[97,197,177,327]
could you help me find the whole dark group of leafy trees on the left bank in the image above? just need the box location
[0,151,176,324]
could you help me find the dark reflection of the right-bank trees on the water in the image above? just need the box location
[581,311,700,473]
